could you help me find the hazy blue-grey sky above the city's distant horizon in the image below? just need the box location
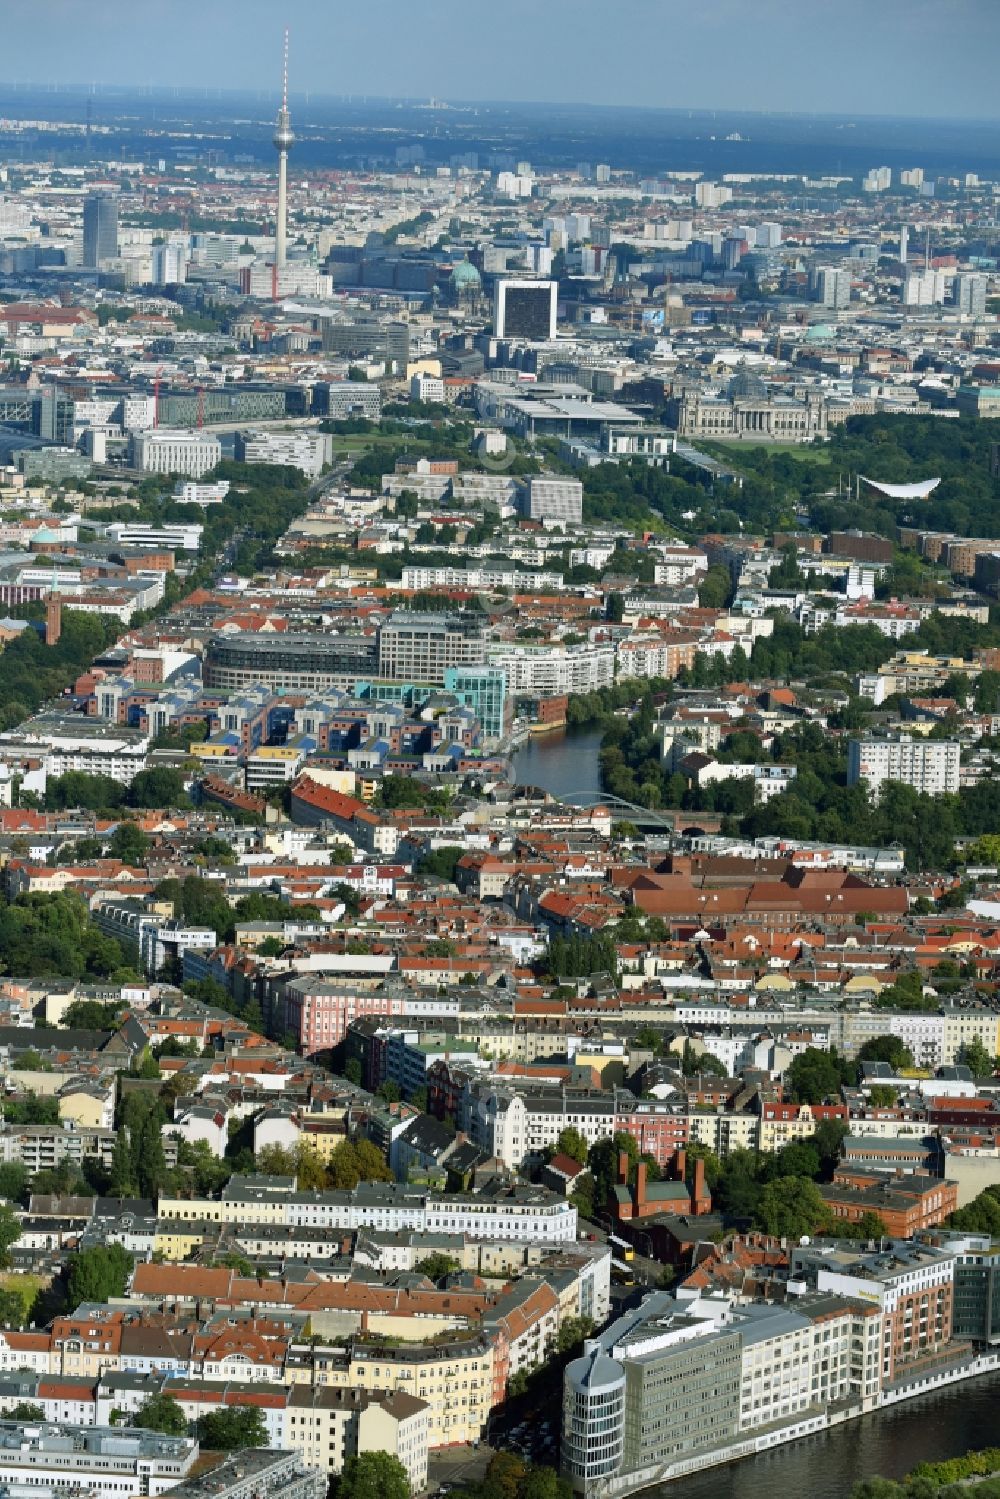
[0,0,1000,120]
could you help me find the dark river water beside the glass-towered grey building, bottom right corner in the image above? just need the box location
[665,1373,1000,1499]
